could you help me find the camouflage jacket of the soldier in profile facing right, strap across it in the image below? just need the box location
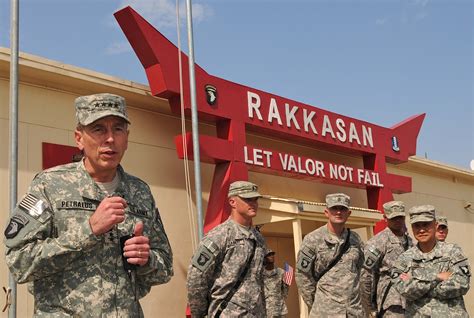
[187,219,266,318]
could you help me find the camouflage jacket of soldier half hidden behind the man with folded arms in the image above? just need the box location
[361,228,413,311]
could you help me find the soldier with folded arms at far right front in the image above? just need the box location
[392,205,471,317]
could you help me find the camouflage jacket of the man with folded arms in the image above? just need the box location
[392,242,471,317]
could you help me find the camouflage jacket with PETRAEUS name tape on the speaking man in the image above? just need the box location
[5,162,173,317]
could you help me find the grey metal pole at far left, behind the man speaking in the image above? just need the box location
[8,0,19,318]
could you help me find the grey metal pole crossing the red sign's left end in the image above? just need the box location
[186,0,204,239]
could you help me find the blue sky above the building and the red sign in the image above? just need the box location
[0,0,474,168]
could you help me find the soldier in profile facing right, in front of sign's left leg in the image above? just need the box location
[187,181,266,318]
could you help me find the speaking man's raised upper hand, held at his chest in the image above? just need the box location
[89,197,127,235]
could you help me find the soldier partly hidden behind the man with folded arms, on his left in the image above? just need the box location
[361,201,413,317]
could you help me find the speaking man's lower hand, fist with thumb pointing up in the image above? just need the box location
[123,222,150,266]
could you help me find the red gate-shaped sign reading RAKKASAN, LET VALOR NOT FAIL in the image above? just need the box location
[115,7,425,232]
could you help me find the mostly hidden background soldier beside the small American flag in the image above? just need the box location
[263,249,290,318]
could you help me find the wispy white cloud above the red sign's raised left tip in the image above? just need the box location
[116,0,214,28]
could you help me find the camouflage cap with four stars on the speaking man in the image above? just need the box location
[74,93,130,126]
